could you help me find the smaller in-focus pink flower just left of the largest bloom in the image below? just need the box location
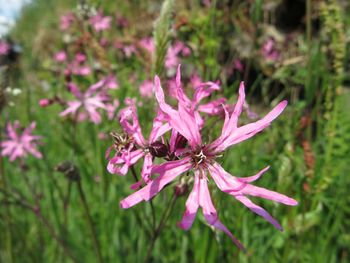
[107,102,170,188]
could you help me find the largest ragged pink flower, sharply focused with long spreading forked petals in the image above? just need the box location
[120,80,297,248]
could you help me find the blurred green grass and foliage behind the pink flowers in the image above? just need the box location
[0,0,350,262]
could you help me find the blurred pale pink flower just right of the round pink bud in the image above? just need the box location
[60,83,107,124]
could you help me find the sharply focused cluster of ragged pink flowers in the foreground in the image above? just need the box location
[107,66,297,248]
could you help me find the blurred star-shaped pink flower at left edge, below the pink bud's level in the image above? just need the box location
[0,121,42,161]
